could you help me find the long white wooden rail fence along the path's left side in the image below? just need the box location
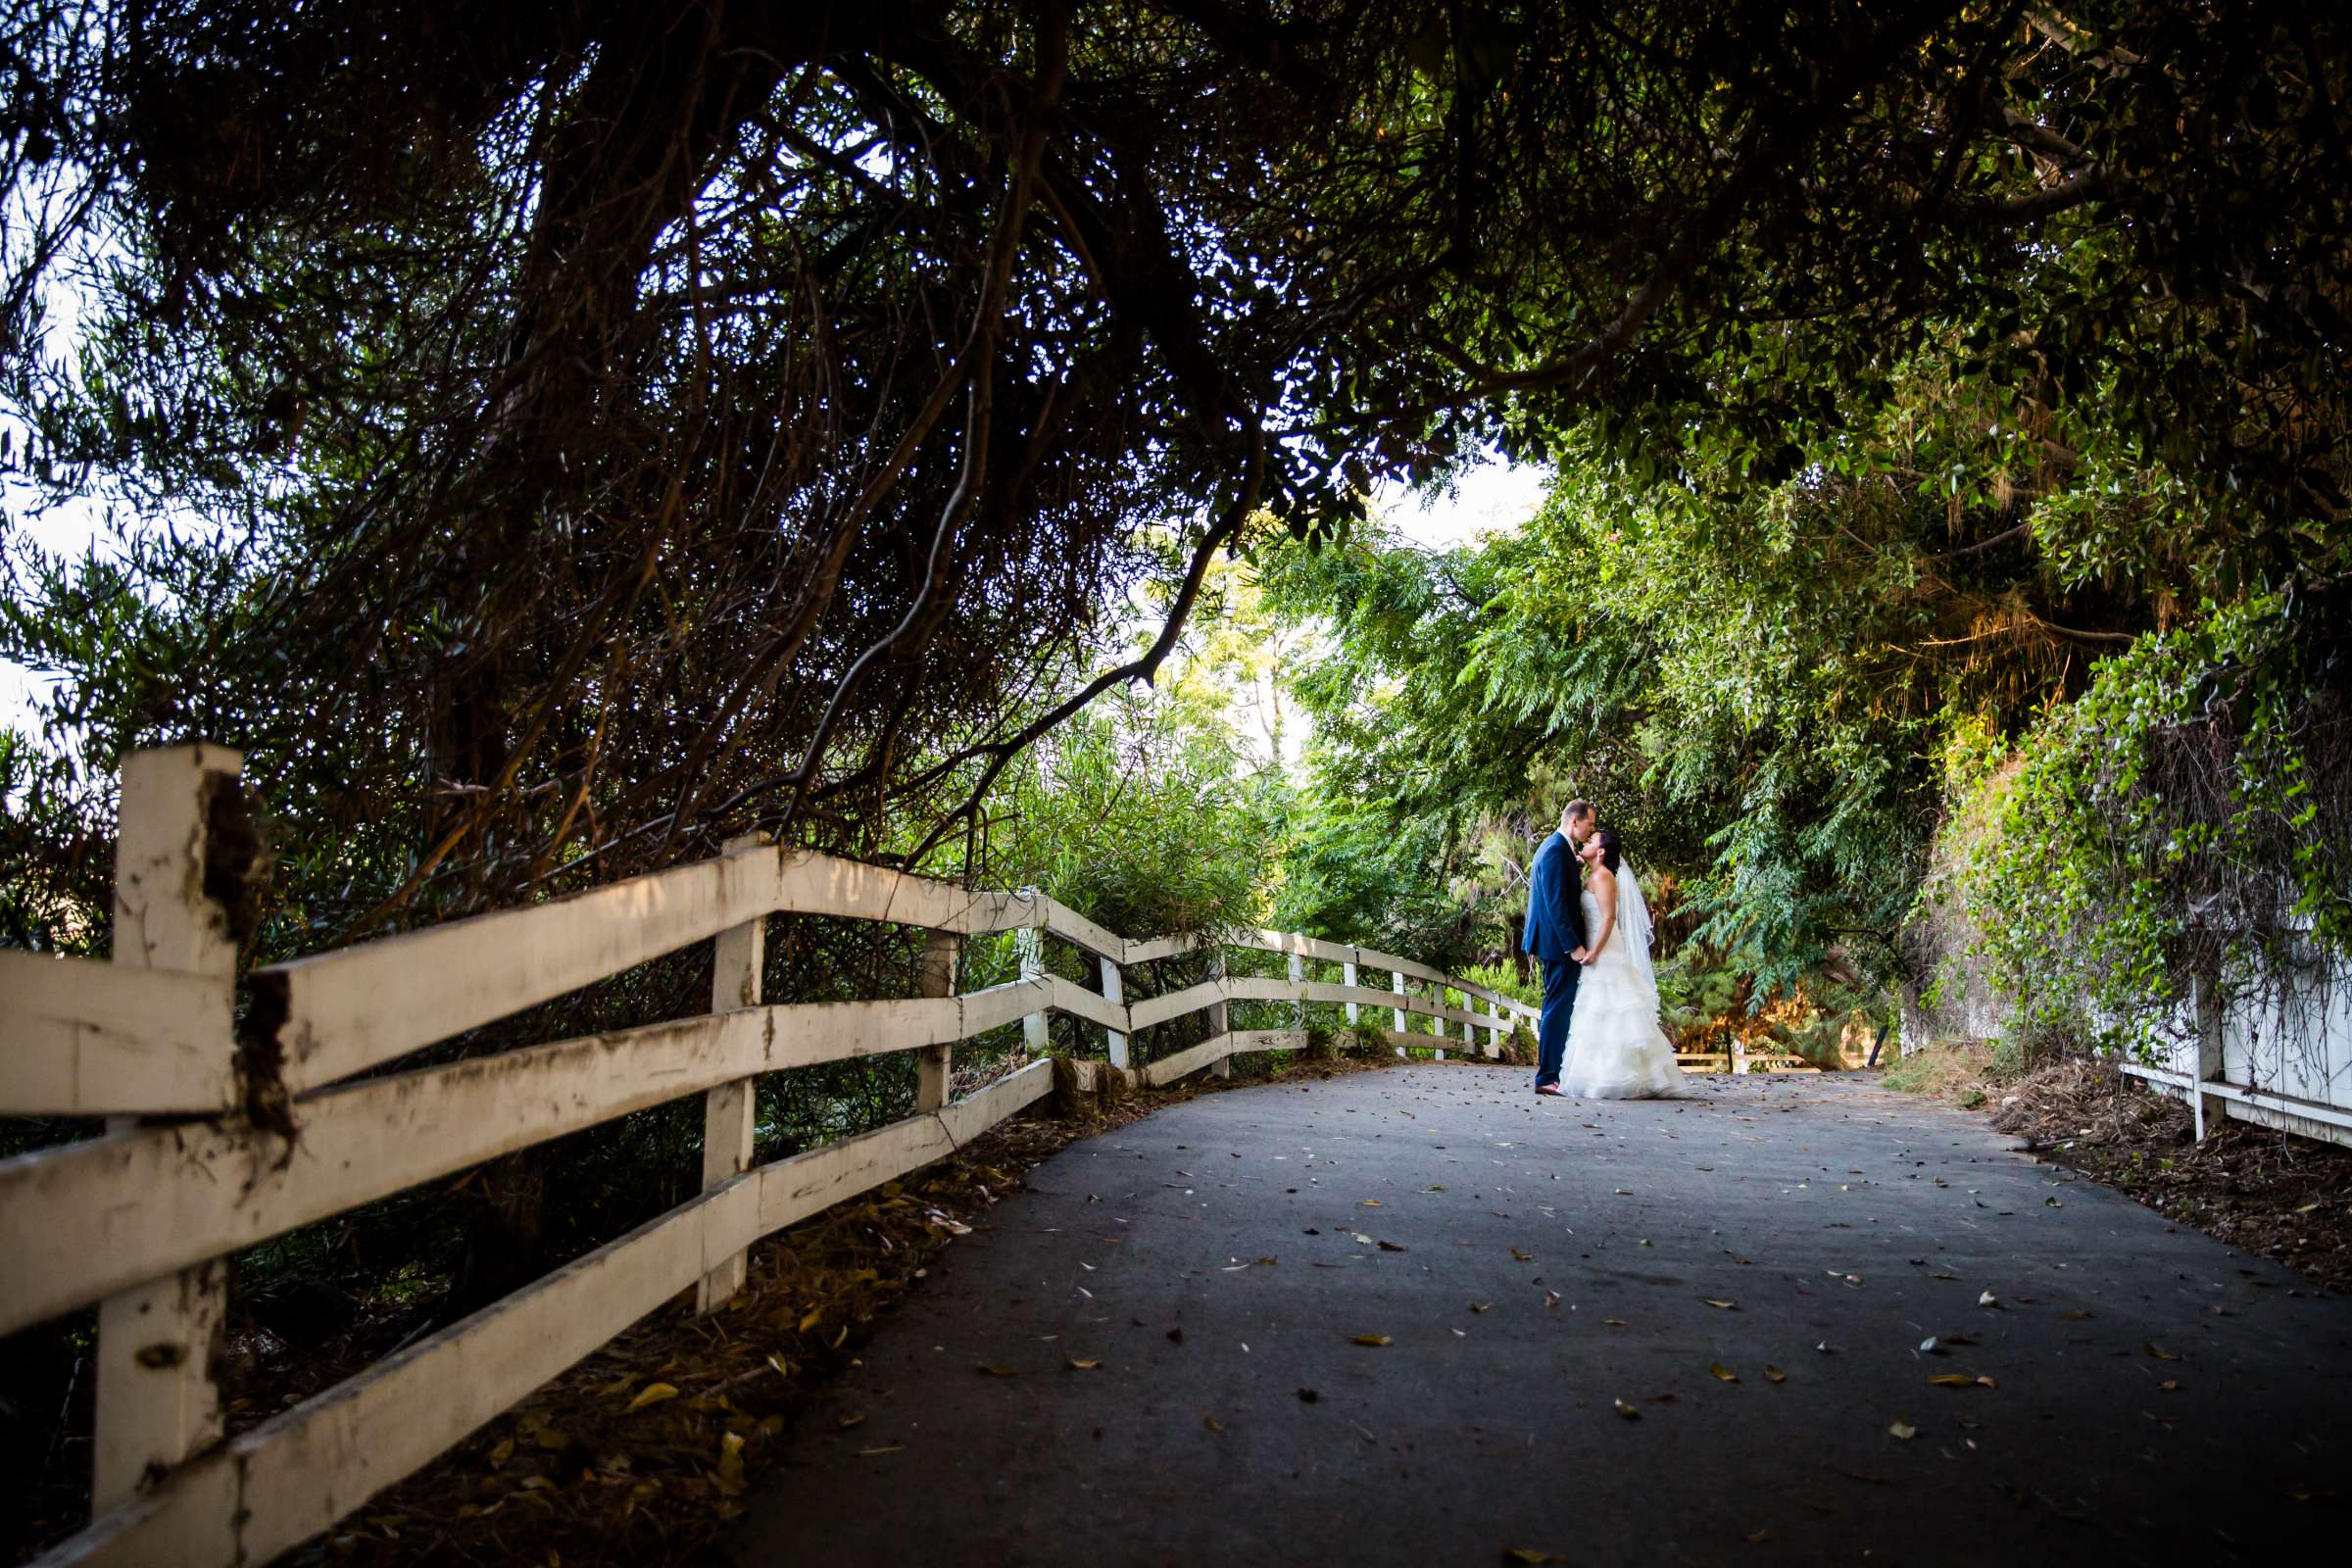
[0,745,1534,1566]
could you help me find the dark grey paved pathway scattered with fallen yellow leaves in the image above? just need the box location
[722,1065,2352,1568]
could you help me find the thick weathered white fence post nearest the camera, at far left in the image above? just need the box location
[89,745,245,1519]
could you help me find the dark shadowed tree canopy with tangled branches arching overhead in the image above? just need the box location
[0,0,2347,958]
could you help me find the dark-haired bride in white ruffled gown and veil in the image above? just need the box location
[1559,827,1682,1101]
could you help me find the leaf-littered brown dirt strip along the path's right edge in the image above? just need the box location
[1903,1055,2352,1291]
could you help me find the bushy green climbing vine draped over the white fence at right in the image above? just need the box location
[1950,595,2352,1046]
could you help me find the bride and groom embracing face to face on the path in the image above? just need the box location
[1519,800,1682,1101]
